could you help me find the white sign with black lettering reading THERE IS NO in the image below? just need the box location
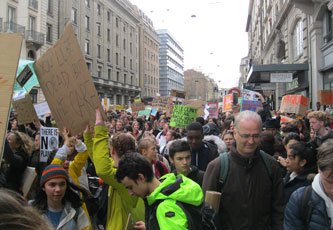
[40,127,59,162]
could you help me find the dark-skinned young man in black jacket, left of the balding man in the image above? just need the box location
[186,122,219,171]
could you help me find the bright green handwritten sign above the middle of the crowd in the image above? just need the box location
[170,105,198,128]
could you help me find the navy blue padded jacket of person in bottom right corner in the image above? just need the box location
[284,187,331,230]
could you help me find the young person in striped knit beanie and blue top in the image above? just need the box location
[32,164,90,230]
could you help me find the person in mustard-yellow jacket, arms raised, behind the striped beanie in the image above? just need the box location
[51,128,92,230]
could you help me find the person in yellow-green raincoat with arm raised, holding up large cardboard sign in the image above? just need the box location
[84,110,144,230]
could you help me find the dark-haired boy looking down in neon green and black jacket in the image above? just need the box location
[116,153,203,230]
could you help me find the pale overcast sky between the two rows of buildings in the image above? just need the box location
[130,0,249,88]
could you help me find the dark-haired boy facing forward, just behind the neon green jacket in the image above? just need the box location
[169,140,205,187]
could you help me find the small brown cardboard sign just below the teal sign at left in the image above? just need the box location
[13,94,38,125]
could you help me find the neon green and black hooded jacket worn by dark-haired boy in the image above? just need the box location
[145,173,203,230]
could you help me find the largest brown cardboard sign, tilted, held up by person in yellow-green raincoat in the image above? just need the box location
[34,23,106,135]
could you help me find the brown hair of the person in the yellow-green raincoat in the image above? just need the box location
[110,133,136,157]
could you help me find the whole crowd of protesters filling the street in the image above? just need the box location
[0,97,333,230]
